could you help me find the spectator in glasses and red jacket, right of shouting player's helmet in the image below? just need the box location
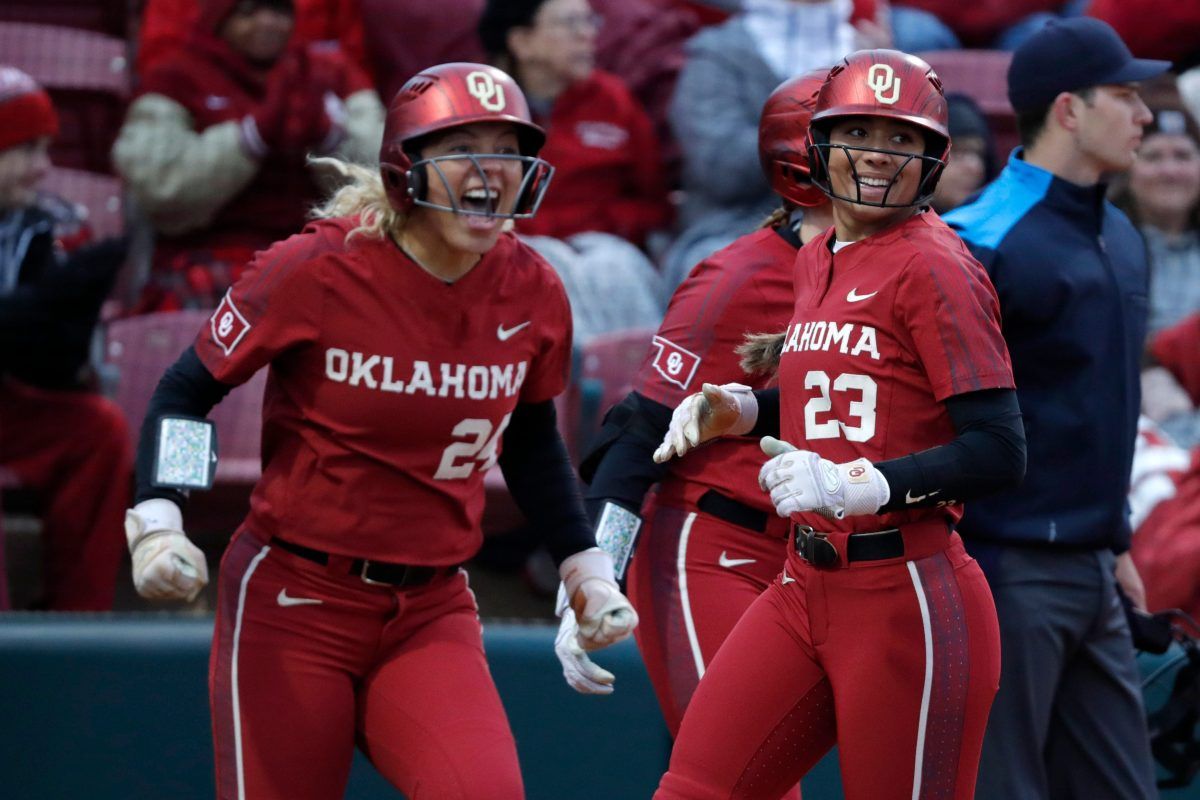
[479,0,671,343]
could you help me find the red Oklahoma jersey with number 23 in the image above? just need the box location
[779,211,1014,531]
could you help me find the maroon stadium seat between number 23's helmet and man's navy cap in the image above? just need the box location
[919,50,1018,162]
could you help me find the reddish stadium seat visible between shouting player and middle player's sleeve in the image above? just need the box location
[574,329,654,451]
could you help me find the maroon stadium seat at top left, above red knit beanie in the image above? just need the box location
[0,22,131,174]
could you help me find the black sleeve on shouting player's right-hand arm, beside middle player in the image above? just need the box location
[499,401,596,566]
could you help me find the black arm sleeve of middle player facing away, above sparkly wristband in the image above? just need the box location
[583,392,673,524]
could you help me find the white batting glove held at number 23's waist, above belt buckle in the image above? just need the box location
[758,437,892,519]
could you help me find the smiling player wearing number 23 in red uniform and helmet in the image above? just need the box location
[655,50,1025,800]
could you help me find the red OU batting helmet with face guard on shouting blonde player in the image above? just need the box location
[379,62,554,219]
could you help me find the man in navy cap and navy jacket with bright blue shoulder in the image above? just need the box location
[946,17,1170,800]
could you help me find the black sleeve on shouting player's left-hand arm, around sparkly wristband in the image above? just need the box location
[134,347,233,509]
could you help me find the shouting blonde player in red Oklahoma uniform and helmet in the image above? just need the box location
[126,64,637,800]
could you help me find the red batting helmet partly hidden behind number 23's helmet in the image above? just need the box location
[758,68,829,206]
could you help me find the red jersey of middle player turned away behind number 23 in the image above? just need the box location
[634,228,796,515]
